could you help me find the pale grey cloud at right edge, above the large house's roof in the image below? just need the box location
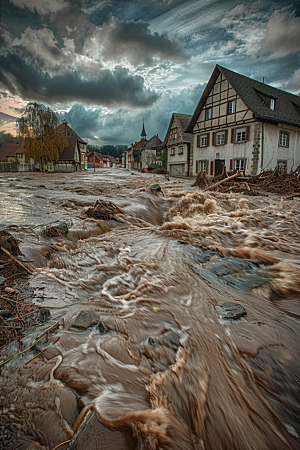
[262,11,300,58]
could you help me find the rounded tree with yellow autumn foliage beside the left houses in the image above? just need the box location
[17,102,68,170]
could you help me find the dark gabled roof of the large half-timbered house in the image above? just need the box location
[186,65,300,132]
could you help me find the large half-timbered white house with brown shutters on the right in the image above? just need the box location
[186,65,300,177]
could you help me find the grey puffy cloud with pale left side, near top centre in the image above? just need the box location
[83,16,188,66]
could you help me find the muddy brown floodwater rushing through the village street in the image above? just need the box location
[0,169,300,450]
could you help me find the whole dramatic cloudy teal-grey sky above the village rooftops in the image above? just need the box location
[0,0,300,145]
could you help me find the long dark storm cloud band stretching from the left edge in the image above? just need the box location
[0,52,158,107]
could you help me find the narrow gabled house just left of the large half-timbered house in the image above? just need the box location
[163,113,192,177]
